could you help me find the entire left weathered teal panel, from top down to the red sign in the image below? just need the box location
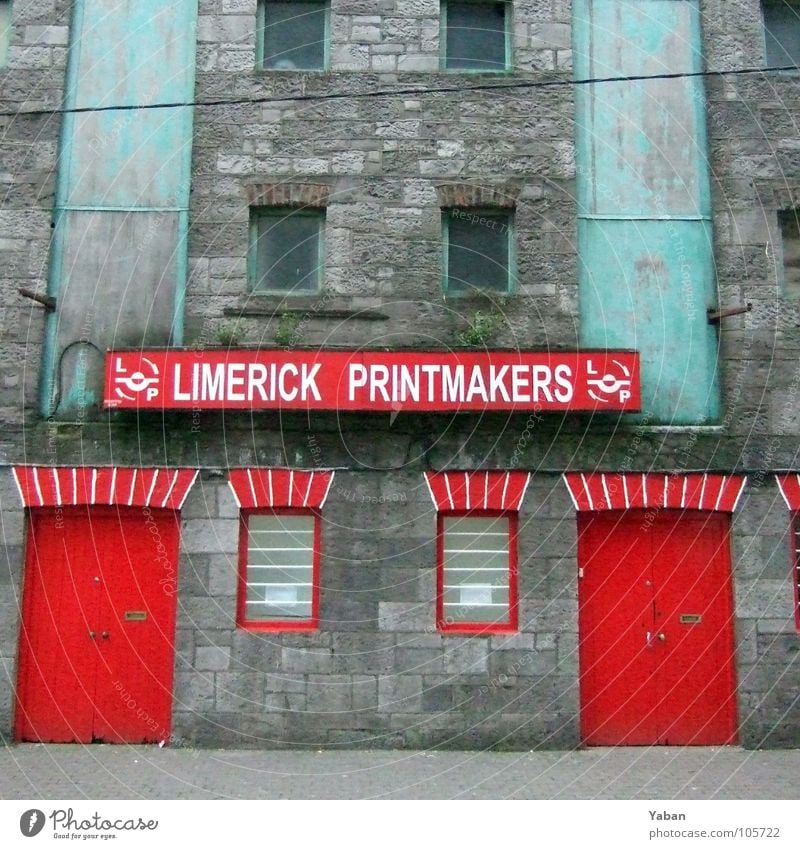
[42,0,197,418]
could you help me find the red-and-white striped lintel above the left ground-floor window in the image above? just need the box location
[228,469,333,510]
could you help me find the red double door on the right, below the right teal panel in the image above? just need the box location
[578,510,736,746]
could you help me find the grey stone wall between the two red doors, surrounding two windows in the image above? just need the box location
[174,472,578,748]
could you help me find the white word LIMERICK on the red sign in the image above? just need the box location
[173,363,322,402]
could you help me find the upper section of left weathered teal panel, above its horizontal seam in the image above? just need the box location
[61,0,197,208]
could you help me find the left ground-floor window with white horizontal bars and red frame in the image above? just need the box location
[240,512,317,624]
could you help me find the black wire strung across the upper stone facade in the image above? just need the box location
[0,65,800,118]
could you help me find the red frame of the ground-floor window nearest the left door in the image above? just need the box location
[236,507,322,631]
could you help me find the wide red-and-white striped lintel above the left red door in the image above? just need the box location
[13,466,197,510]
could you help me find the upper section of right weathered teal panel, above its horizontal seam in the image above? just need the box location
[573,0,711,217]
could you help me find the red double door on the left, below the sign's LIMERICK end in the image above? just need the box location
[16,507,178,743]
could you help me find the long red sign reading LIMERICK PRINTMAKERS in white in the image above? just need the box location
[104,349,640,412]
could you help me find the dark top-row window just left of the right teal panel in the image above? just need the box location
[441,0,511,71]
